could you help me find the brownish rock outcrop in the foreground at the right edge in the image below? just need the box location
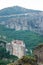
[34,44,43,62]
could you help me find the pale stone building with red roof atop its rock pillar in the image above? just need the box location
[7,40,26,58]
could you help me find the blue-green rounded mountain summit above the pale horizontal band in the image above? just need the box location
[0,6,42,15]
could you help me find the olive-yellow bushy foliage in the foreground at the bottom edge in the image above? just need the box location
[8,56,37,65]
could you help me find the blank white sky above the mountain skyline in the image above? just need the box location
[0,0,43,11]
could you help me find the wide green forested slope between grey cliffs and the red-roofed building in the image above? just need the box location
[0,26,43,49]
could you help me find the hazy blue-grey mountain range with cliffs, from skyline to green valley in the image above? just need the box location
[0,6,43,34]
